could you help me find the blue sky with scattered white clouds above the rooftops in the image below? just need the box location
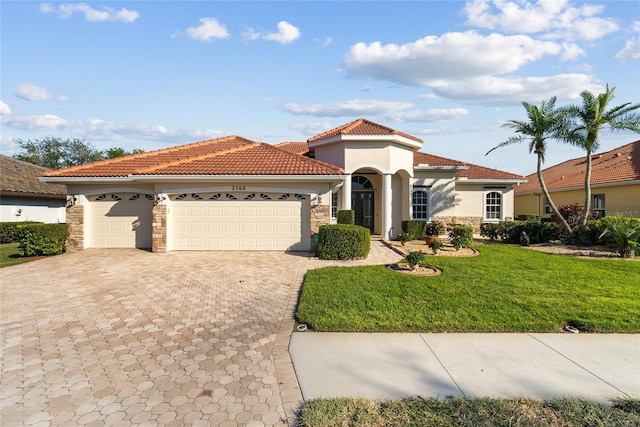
[0,0,640,175]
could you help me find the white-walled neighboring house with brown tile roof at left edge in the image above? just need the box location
[0,155,67,223]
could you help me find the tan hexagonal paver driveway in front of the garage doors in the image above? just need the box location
[0,250,309,427]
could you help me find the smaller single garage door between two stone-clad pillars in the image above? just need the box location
[89,193,153,248]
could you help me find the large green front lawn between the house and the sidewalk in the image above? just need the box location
[296,245,640,333]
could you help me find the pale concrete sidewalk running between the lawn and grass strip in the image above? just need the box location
[289,332,640,403]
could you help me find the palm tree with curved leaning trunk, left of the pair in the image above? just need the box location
[485,96,573,235]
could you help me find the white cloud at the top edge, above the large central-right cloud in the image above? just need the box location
[462,0,619,40]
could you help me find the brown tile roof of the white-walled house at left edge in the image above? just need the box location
[0,155,67,198]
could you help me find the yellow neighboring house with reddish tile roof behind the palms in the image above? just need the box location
[515,140,640,218]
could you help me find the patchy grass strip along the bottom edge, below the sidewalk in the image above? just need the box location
[297,398,640,427]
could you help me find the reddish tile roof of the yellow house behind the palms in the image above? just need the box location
[516,140,640,193]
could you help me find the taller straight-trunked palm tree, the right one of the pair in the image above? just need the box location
[562,85,640,226]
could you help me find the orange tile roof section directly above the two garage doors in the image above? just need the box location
[44,136,342,177]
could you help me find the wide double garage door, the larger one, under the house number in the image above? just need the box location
[170,193,310,251]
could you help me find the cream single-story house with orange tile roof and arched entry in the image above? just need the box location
[43,119,525,252]
